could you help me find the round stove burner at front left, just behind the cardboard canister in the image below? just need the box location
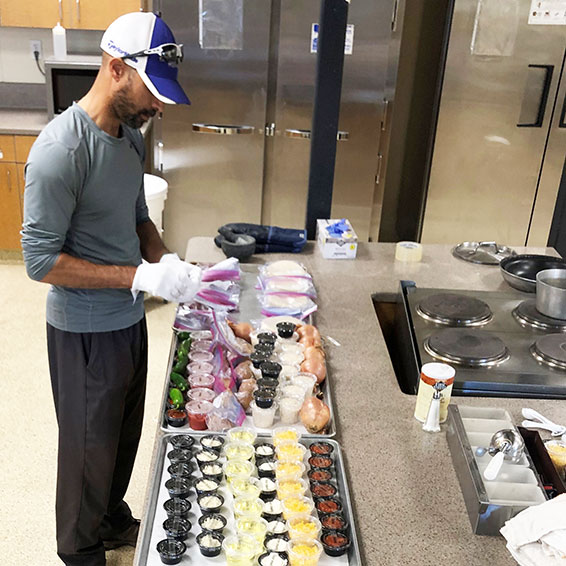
[424,328,510,367]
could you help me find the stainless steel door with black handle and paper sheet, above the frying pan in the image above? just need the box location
[422,0,566,245]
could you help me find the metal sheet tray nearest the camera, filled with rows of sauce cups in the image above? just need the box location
[134,434,362,566]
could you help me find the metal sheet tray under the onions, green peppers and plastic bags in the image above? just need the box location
[160,266,336,438]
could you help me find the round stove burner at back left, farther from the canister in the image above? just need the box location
[417,293,493,326]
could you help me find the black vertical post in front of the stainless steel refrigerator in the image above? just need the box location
[306,0,349,240]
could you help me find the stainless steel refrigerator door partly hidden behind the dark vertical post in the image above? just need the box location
[262,0,392,239]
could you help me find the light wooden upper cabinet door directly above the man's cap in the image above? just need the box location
[65,0,142,30]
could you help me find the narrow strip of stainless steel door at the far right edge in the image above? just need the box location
[527,53,566,246]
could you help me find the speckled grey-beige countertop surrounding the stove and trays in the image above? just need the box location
[145,238,566,566]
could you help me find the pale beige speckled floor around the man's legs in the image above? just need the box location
[0,263,178,566]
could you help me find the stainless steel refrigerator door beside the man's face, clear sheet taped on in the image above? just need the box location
[161,0,271,254]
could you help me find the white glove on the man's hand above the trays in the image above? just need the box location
[131,262,201,303]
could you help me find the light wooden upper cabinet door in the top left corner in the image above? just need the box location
[0,0,65,28]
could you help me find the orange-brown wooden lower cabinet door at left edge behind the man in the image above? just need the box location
[0,162,22,250]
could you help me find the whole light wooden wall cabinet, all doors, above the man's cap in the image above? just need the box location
[0,0,147,30]
